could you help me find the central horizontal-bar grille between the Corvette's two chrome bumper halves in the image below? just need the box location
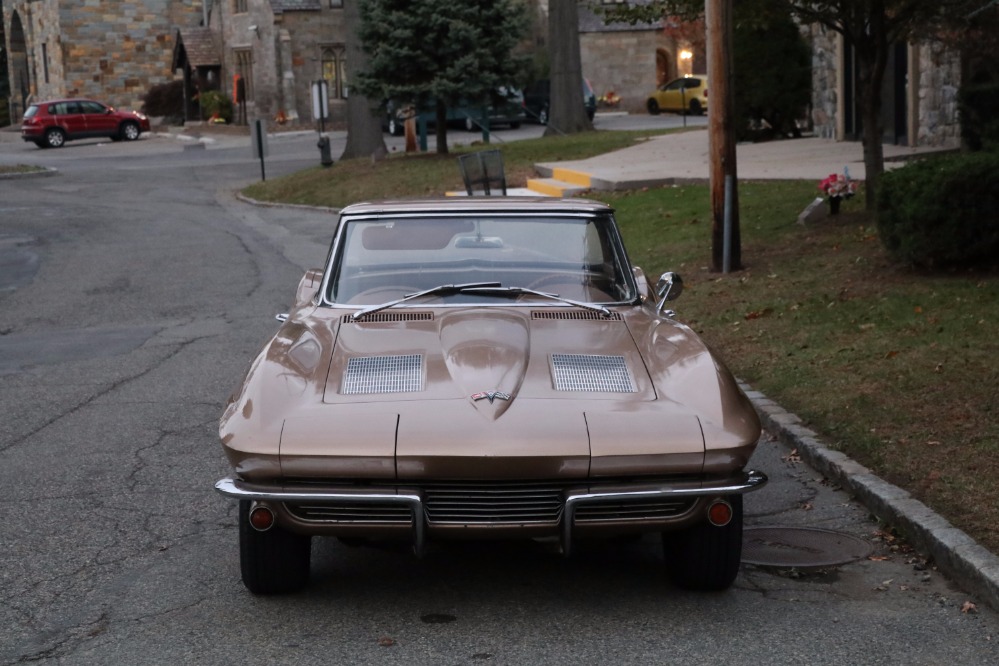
[424,482,563,525]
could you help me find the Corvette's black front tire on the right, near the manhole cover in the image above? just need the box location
[663,495,742,592]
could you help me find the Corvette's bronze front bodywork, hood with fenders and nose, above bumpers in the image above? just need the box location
[220,307,759,479]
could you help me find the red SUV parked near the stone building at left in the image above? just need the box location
[21,99,149,148]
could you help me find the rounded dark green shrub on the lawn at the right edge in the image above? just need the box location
[877,152,999,268]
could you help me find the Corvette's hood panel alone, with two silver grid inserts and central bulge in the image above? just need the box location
[323,308,656,412]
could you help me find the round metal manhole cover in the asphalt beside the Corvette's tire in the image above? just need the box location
[742,527,871,567]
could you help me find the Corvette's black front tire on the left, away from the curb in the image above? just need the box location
[239,500,312,594]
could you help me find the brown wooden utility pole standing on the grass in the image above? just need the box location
[704,0,742,272]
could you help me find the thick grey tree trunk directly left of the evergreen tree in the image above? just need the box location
[340,0,388,160]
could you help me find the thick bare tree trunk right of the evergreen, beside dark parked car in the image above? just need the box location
[545,0,593,136]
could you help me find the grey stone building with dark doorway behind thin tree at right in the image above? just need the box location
[807,26,961,148]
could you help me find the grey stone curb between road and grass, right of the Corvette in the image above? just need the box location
[743,385,999,610]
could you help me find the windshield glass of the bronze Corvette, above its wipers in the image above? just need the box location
[325,215,636,307]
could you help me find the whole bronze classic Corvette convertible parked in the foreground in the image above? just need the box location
[215,197,766,594]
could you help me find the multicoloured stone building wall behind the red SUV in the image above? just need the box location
[0,0,204,122]
